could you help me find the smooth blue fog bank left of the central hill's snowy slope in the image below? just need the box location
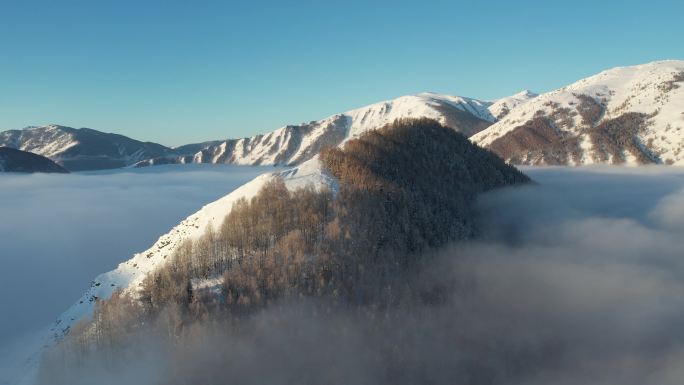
[0,165,273,378]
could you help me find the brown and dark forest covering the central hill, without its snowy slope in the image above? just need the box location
[44,119,529,383]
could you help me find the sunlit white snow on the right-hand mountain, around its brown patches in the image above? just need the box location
[471,60,684,165]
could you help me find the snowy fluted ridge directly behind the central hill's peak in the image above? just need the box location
[138,92,534,166]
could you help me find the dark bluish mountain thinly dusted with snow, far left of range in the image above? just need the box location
[0,125,203,171]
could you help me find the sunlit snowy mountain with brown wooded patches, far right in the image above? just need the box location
[471,60,684,165]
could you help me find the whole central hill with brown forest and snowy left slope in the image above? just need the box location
[40,119,529,382]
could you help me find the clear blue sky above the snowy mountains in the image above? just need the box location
[0,0,684,145]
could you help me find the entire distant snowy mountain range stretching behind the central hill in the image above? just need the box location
[0,60,684,171]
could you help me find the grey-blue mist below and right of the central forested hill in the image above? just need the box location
[37,160,684,385]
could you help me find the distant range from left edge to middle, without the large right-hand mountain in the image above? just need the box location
[0,91,536,171]
